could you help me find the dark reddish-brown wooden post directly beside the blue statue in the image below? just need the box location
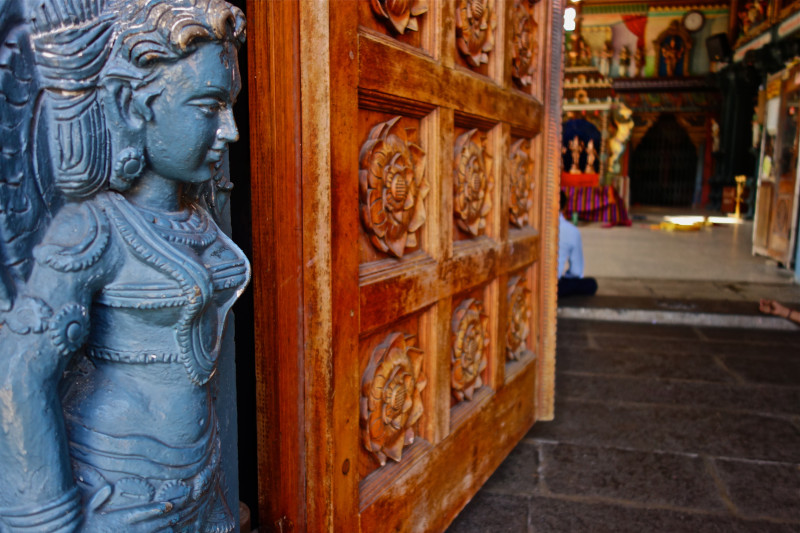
[247,0,306,531]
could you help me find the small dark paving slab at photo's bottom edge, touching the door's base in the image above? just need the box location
[447,490,530,533]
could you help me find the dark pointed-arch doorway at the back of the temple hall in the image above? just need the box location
[630,113,697,207]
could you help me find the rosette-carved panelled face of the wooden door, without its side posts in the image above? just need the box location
[354,1,544,531]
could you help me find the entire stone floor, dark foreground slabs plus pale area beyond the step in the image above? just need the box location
[448,209,800,533]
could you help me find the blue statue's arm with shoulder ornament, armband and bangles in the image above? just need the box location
[0,205,114,531]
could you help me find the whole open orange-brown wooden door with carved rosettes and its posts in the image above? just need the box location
[248,0,562,532]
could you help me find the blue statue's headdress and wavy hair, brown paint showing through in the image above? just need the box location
[31,0,244,199]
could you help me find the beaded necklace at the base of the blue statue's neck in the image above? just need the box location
[135,205,217,252]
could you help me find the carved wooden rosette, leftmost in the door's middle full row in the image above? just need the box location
[358,117,430,257]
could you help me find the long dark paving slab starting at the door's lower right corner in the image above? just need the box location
[527,399,800,462]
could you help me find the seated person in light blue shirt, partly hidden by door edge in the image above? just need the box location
[558,191,597,298]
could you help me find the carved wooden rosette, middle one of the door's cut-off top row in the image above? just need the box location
[456,0,497,67]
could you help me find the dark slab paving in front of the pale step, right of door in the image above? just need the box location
[448,319,800,533]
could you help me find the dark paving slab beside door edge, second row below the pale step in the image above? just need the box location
[556,349,737,382]
